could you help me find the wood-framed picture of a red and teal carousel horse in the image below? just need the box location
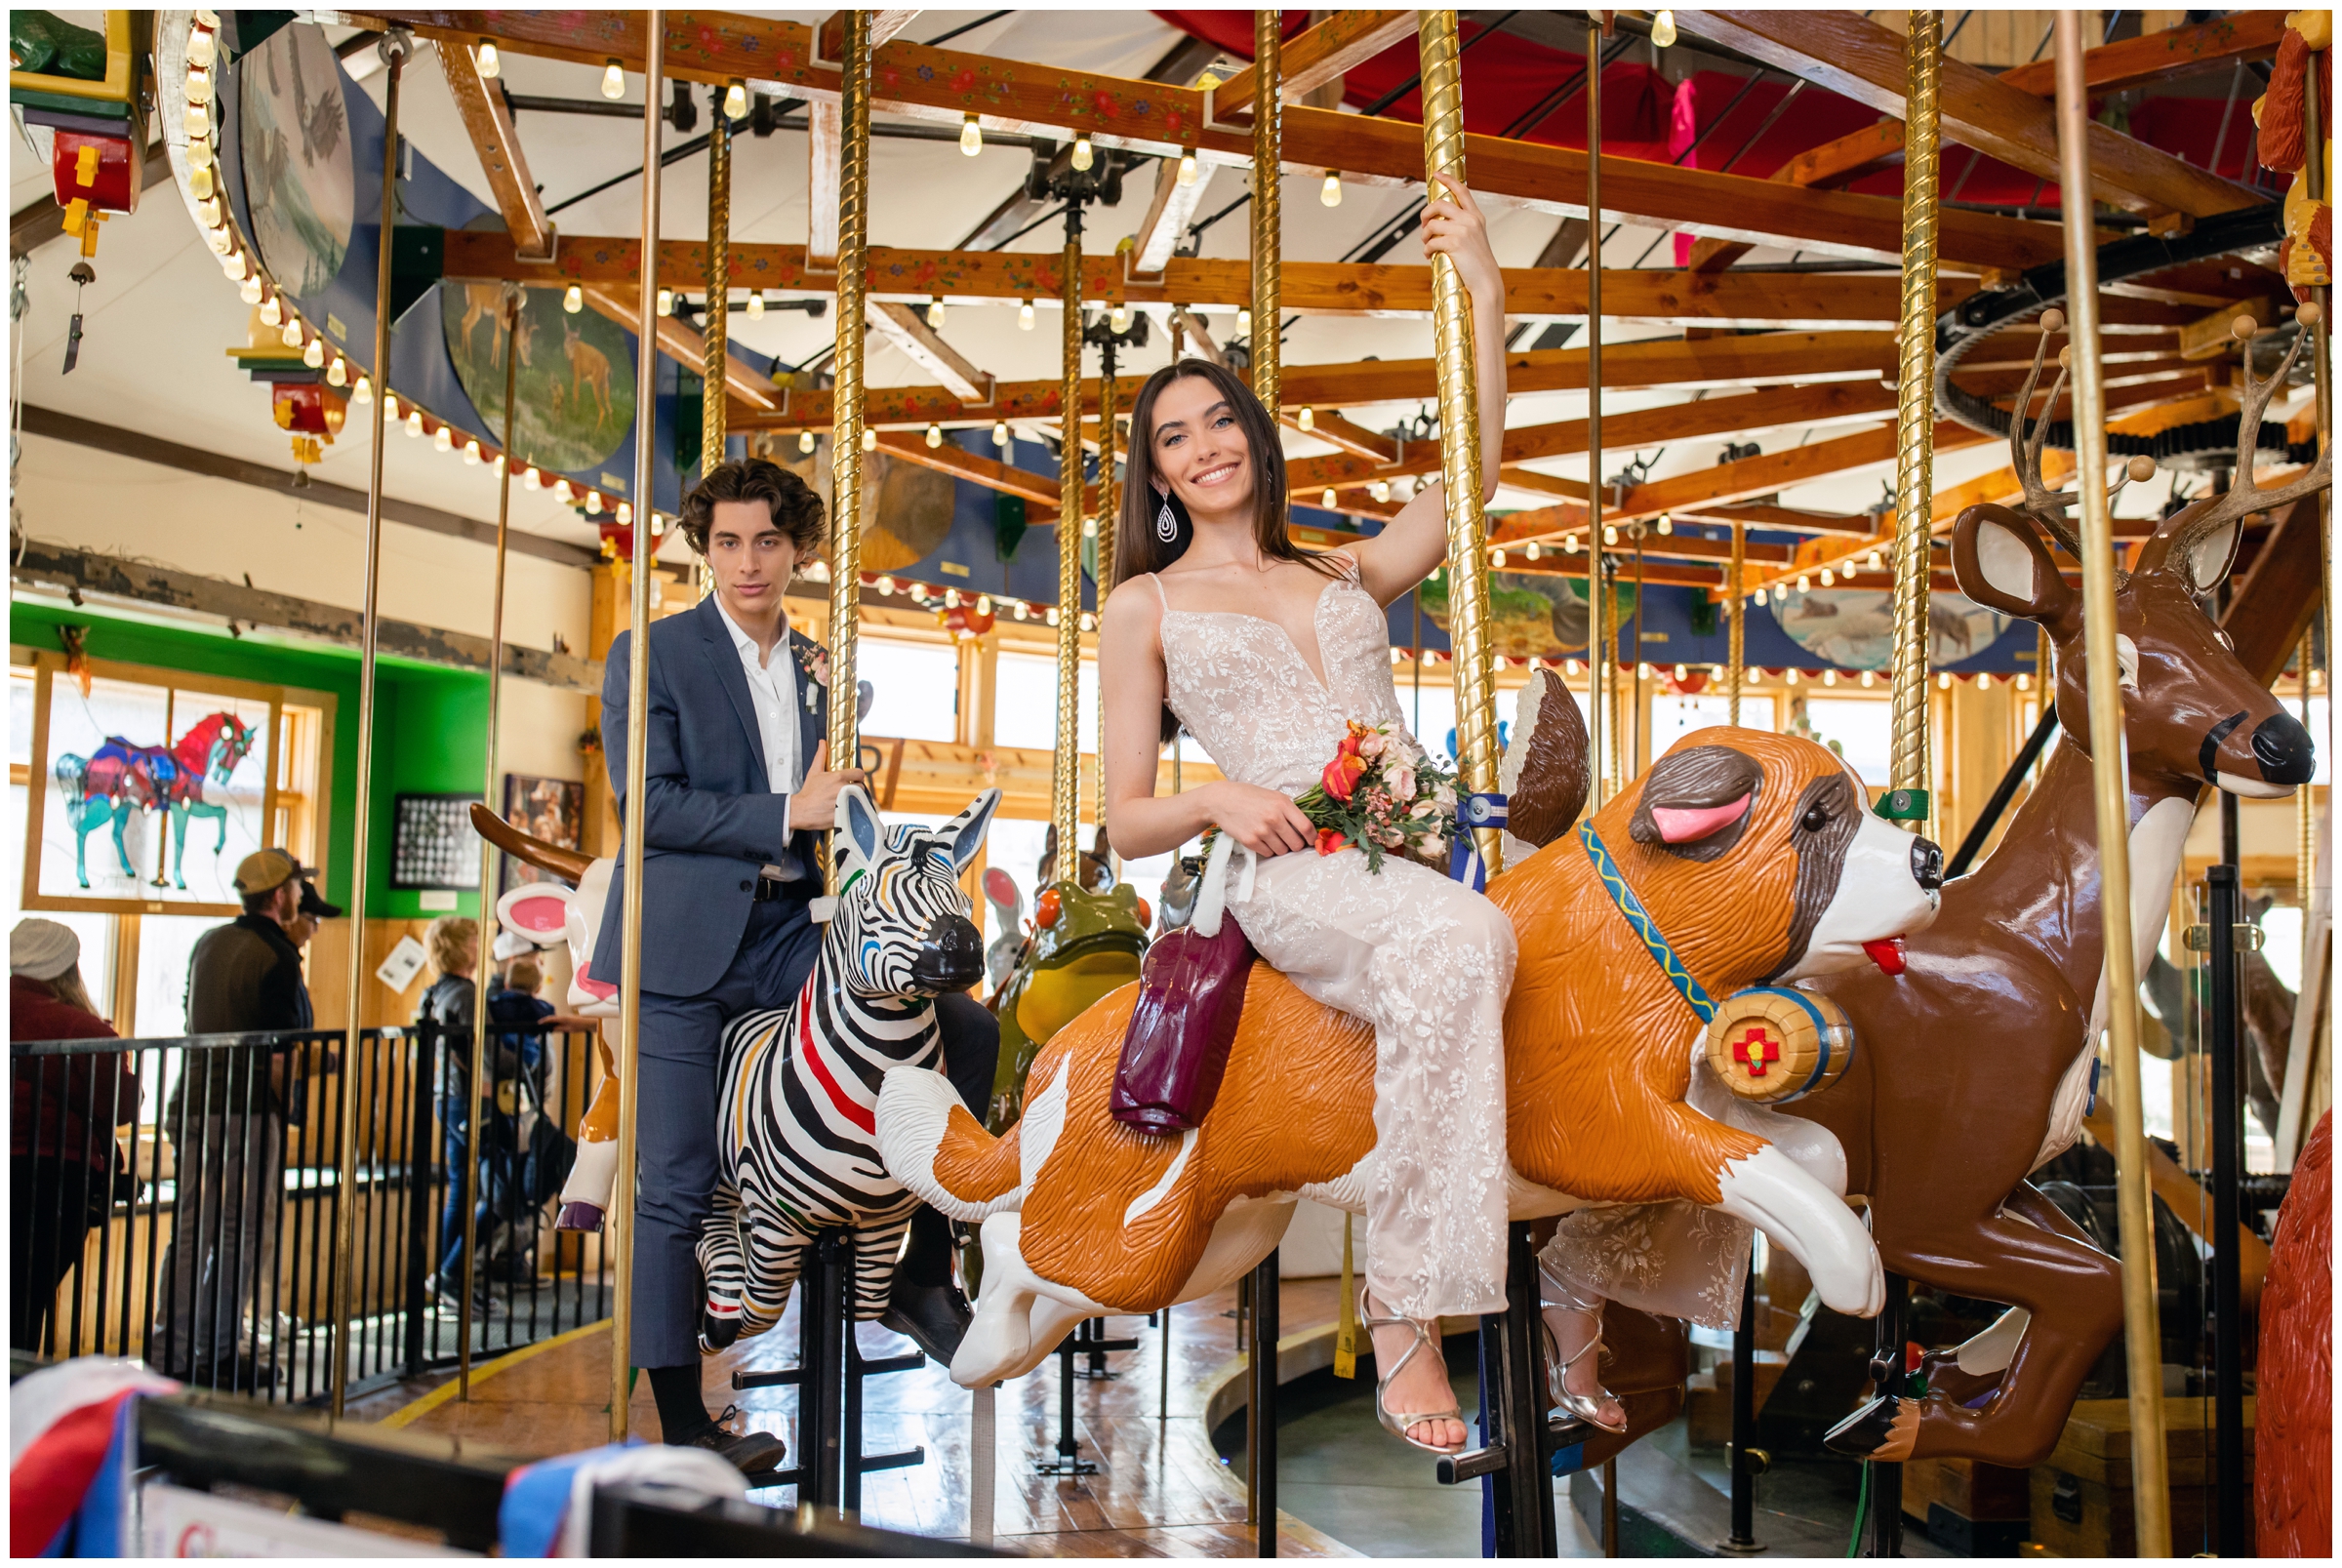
[23,653,283,917]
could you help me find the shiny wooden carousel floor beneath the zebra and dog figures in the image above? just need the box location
[379,1280,1358,1556]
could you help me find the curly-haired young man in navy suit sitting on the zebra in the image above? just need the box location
[592,459,1000,1474]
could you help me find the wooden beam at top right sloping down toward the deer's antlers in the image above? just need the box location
[1676,12,2260,218]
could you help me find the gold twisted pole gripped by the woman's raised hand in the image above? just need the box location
[1405,12,1504,875]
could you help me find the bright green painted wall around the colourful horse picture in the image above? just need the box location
[10,604,502,920]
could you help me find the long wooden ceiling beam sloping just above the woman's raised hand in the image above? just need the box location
[349,12,2063,271]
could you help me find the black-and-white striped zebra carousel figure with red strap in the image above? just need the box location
[698,788,1000,1350]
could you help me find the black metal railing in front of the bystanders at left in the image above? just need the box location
[10,1023,609,1402]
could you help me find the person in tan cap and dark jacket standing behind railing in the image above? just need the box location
[150,847,320,1390]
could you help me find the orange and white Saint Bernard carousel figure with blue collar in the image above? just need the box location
[878,674,1937,1386]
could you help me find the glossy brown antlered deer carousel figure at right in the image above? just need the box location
[1790,323,2332,1467]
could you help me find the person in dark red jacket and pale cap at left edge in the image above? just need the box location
[7,920,139,1355]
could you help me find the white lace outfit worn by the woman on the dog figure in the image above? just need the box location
[1154,566,1513,1317]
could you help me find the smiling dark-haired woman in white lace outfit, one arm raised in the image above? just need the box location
[1099,181,1546,1451]
